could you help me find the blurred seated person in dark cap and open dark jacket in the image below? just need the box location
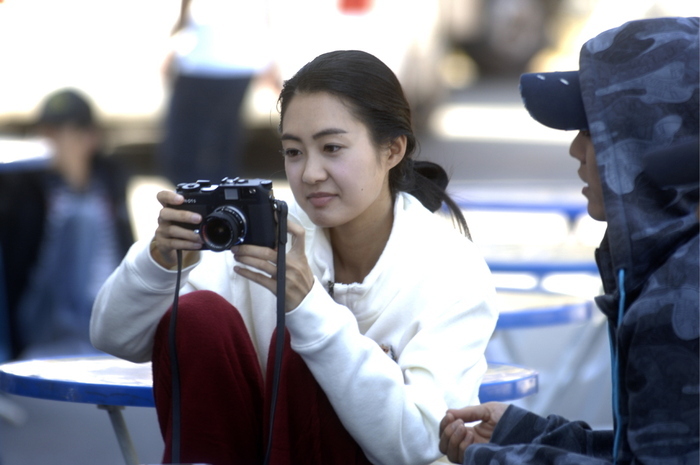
[0,89,133,358]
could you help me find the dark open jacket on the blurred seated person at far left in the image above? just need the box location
[0,154,134,358]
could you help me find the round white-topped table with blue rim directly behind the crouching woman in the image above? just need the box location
[0,355,538,465]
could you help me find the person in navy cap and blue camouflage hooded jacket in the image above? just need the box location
[440,18,700,465]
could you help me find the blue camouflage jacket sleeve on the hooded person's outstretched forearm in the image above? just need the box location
[464,405,613,465]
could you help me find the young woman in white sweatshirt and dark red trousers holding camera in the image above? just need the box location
[92,51,497,465]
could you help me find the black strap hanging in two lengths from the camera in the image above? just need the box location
[168,200,287,465]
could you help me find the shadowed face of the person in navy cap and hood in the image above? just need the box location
[569,131,605,221]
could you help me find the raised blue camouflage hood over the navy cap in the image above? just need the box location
[579,18,700,292]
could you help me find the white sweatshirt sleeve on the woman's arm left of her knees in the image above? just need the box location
[90,240,200,363]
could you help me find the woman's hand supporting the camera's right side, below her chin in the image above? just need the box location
[231,221,314,312]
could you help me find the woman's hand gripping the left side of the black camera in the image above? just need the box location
[151,191,202,268]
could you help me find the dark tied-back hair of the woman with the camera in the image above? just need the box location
[278,50,470,237]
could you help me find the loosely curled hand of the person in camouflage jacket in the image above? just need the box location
[440,402,508,463]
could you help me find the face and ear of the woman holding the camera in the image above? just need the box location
[282,92,405,228]
